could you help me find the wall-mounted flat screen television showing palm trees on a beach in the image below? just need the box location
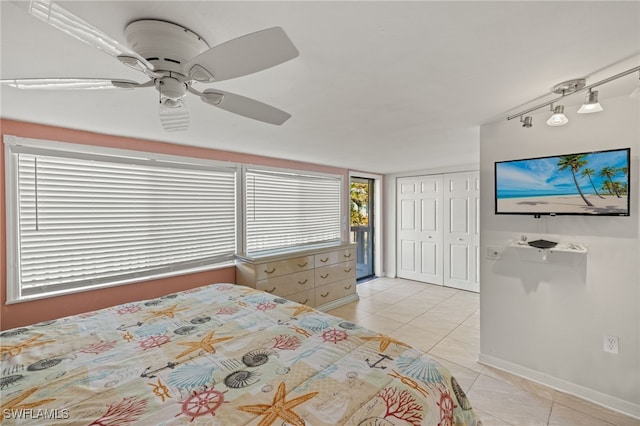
[495,148,631,216]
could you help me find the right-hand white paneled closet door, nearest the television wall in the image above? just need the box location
[444,172,480,292]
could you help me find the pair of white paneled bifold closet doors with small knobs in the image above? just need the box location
[397,172,480,292]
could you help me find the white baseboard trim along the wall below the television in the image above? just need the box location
[478,354,640,420]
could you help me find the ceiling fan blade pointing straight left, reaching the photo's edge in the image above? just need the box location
[0,78,146,90]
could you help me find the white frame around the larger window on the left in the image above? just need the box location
[4,135,243,304]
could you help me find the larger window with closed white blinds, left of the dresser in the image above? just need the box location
[5,136,237,302]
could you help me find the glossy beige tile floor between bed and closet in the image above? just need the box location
[329,278,640,426]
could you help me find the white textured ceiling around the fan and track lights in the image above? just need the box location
[0,1,640,173]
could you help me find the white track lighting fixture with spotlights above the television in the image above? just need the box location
[507,66,640,128]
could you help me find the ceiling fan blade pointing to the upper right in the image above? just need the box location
[185,27,299,81]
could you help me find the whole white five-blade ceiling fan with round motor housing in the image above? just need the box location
[0,0,298,132]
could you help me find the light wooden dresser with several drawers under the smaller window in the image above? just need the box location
[236,243,358,311]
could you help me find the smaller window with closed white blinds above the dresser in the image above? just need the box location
[244,168,342,253]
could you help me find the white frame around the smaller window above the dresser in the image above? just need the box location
[238,164,345,256]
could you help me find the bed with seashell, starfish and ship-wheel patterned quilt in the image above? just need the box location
[0,284,481,426]
